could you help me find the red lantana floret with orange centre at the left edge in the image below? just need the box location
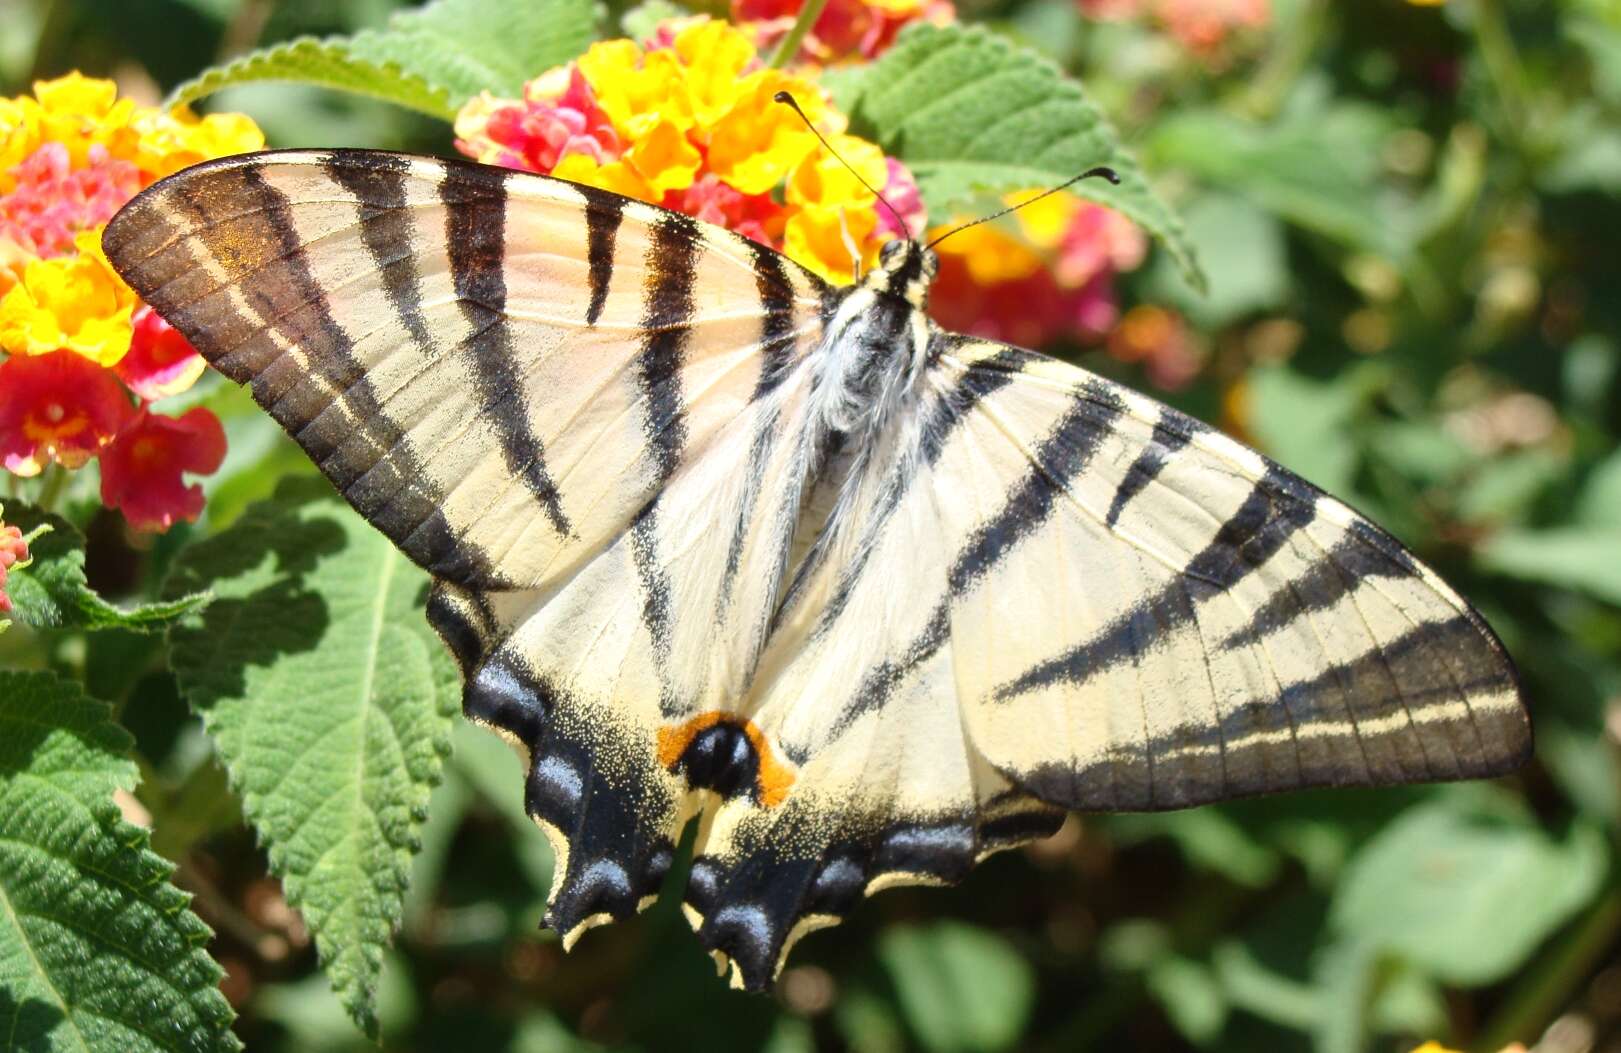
[0,352,135,476]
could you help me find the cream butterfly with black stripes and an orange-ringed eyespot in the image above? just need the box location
[104,143,1532,990]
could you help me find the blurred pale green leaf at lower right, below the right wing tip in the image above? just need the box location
[1329,794,1608,985]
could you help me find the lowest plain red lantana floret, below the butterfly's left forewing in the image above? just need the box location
[101,407,225,530]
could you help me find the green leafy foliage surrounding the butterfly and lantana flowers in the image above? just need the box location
[0,0,1621,1053]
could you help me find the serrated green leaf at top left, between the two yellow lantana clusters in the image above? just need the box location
[169,0,597,120]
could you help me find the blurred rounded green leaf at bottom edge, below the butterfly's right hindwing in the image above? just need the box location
[879,922,1036,1053]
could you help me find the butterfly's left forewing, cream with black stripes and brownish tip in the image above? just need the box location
[105,151,820,588]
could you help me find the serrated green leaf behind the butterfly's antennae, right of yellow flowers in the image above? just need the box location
[840,23,1206,290]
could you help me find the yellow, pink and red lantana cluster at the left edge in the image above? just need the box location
[0,73,264,530]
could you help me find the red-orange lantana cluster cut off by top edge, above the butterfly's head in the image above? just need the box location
[731,0,956,66]
